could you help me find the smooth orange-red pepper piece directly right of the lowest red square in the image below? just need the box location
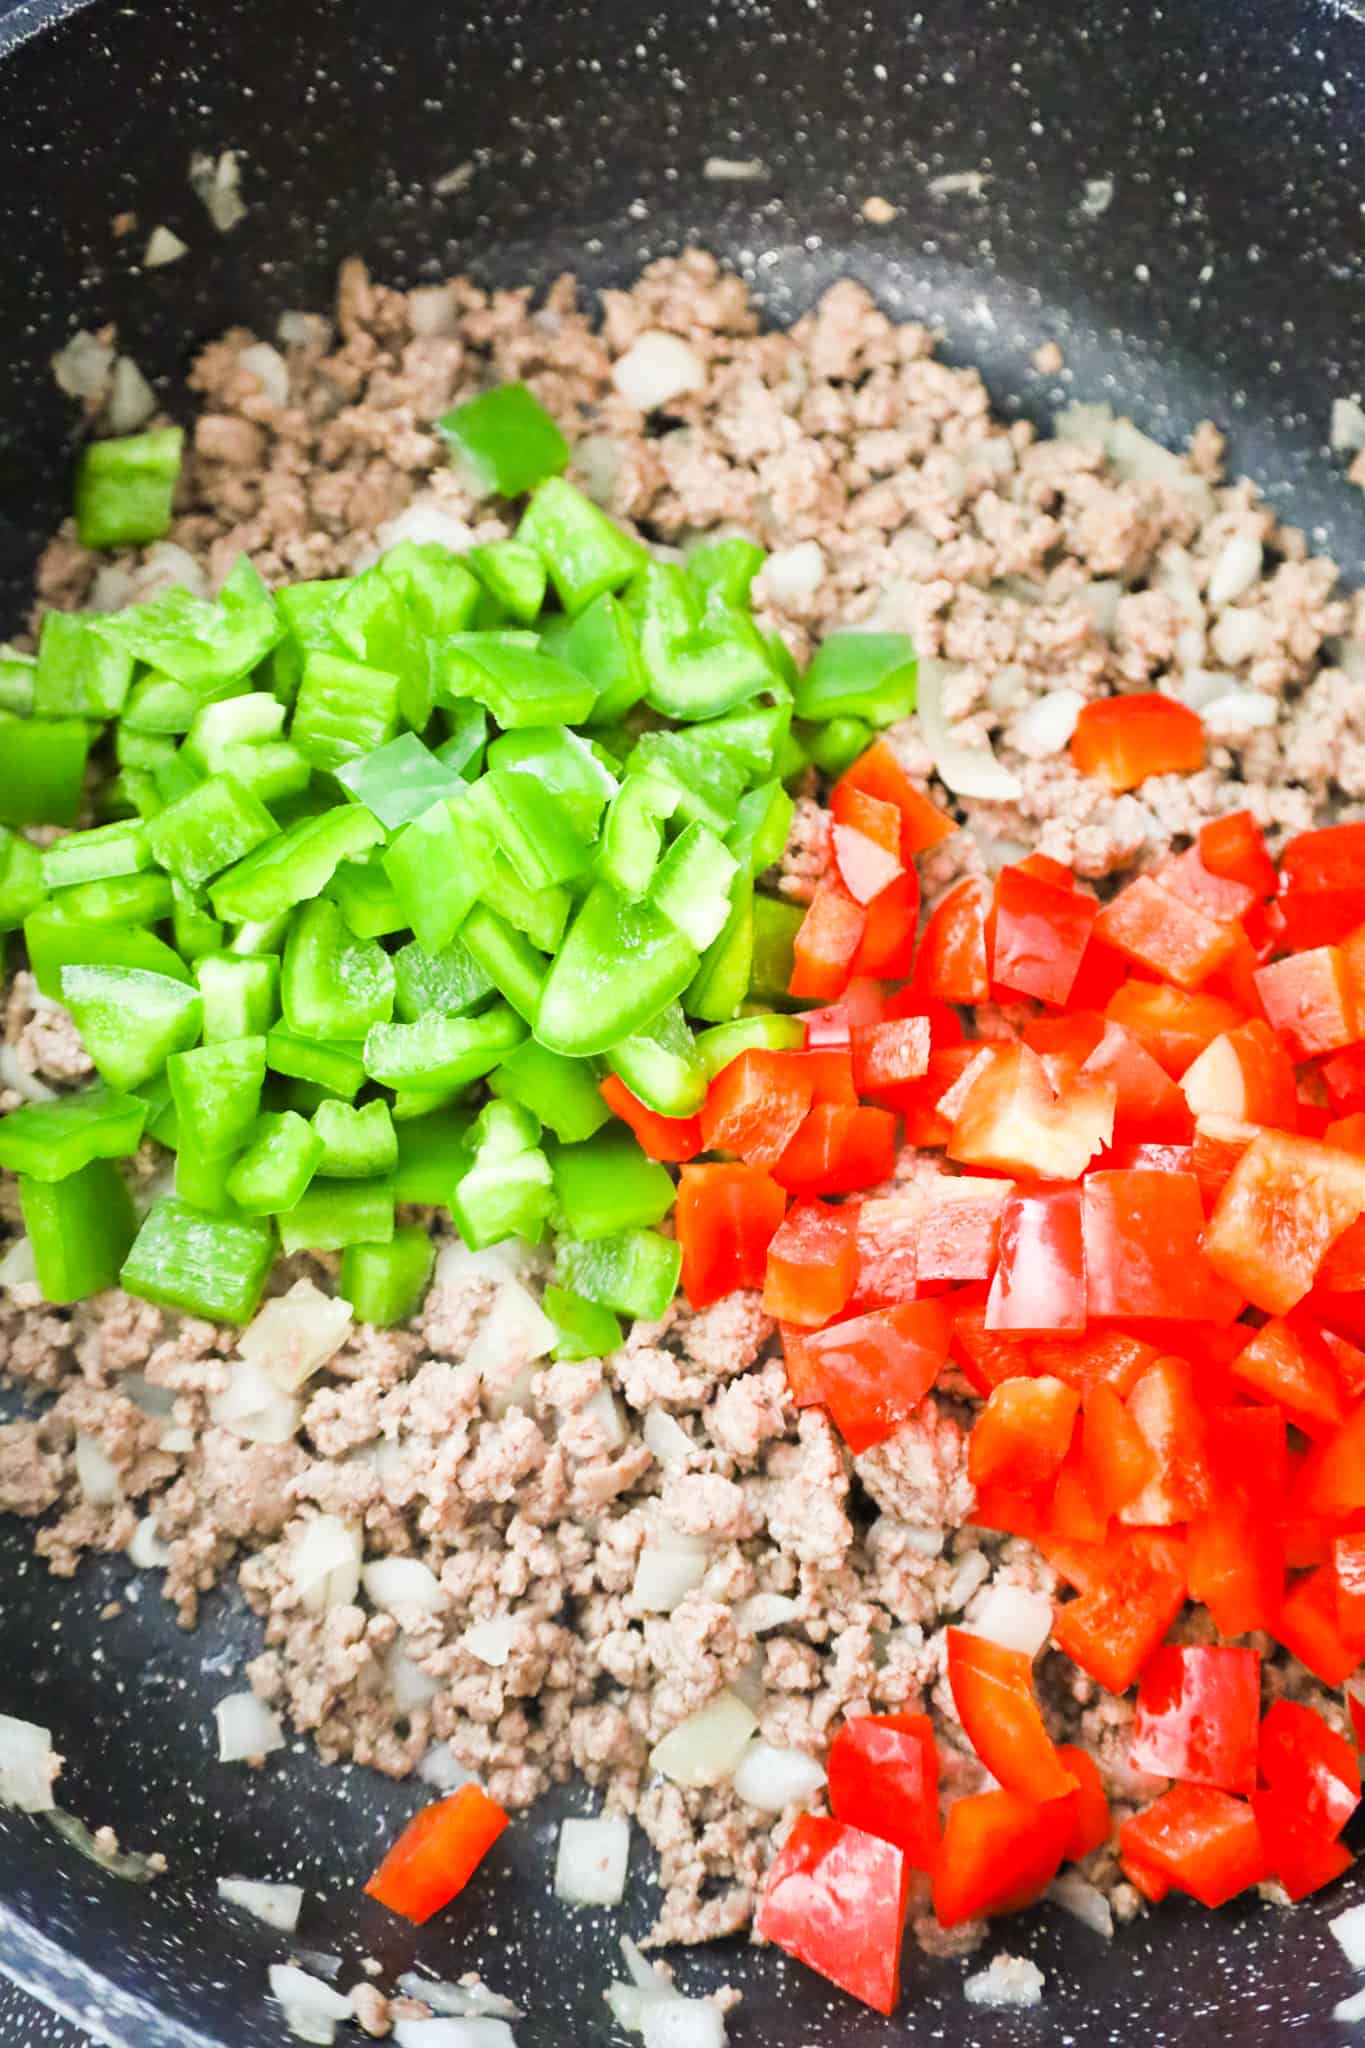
[933,1792,1076,1927]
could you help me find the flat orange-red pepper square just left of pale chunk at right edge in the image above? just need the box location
[1083,1171,1242,1323]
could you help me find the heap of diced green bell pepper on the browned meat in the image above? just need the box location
[0,385,915,1356]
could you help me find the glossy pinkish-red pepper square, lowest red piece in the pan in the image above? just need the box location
[755,1812,911,2013]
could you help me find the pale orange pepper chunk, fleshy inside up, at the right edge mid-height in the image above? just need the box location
[1203,1130,1365,1315]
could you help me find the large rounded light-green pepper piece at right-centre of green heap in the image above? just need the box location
[536,883,698,1057]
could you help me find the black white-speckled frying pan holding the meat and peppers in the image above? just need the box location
[0,0,1365,2048]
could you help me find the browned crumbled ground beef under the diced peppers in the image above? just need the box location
[0,256,1365,1966]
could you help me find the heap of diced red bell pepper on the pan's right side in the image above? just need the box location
[608,733,1365,2011]
